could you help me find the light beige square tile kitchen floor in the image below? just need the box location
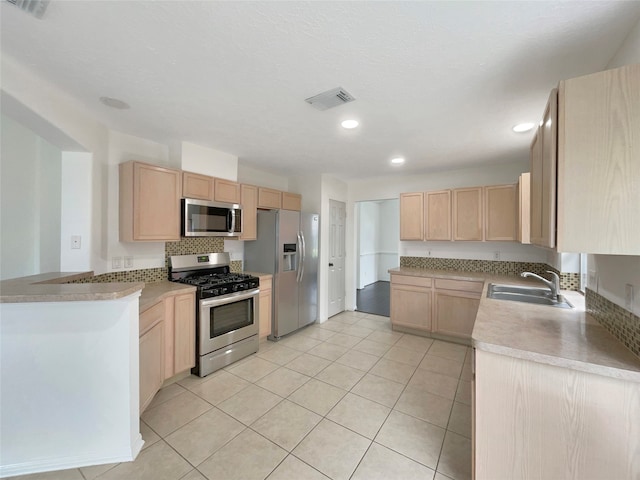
[15,312,471,480]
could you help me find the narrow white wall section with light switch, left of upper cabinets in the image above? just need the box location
[60,152,93,272]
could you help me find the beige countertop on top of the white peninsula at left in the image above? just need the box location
[0,272,144,303]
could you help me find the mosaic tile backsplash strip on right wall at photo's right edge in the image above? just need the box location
[585,288,640,357]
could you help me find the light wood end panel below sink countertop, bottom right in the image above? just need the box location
[472,349,640,480]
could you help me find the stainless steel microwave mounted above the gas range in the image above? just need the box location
[181,198,242,237]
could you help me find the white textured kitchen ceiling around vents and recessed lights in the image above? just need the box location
[0,0,640,180]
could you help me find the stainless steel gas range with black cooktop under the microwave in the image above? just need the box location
[169,253,260,377]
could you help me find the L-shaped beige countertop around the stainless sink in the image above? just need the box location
[389,267,640,382]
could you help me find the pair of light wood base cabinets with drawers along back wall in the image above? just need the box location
[391,274,484,344]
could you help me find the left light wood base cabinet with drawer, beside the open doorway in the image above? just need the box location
[390,275,432,331]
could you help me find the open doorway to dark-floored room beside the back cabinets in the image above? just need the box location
[356,199,400,317]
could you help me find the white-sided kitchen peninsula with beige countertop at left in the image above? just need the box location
[0,272,144,477]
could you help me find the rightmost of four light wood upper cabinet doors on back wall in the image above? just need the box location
[484,185,518,241]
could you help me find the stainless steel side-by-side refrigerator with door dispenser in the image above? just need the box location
[244,210,320,340]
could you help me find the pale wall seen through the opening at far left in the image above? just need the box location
[0,115,62,279]
